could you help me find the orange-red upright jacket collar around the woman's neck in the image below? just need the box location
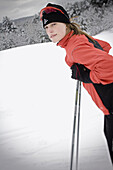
[57,30,74,48]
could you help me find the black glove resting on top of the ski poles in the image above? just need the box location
[71,63,93,83]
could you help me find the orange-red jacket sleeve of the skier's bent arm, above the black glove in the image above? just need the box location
[71,42,113,84]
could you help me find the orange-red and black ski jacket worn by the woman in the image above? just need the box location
[57,31,113,115]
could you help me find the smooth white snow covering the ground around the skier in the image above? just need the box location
[0,29,113,170]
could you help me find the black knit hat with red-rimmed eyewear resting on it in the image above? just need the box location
[40,3,70,27]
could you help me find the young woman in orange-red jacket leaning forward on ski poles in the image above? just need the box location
[40,3,113,164]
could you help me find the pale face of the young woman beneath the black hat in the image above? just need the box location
[45,22,66,43]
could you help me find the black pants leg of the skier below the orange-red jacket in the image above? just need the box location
[104,115,113,164]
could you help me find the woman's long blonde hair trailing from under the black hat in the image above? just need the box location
[66,23,95,43]
